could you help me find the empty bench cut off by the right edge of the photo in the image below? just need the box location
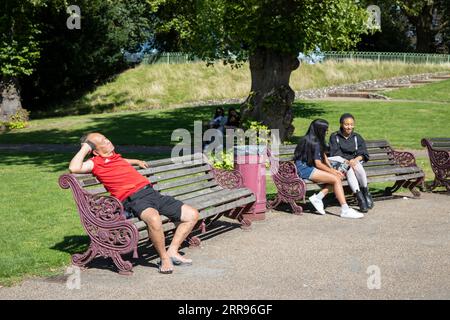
[421,138,450,191]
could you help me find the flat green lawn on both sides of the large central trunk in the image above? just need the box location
[0,100,450,149]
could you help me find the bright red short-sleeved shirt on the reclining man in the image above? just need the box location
[91,153,151,201]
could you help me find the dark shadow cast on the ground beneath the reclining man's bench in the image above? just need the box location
[50,220,240,272]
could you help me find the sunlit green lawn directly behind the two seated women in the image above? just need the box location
[292,101,450,149]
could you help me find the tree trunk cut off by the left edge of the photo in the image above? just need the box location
[0,77,22,121]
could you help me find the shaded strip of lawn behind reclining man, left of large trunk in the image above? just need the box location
[0,104,237,146]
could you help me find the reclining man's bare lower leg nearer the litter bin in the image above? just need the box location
[167,204,199,263]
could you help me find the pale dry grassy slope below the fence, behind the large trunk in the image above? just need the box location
[37,61,450,115]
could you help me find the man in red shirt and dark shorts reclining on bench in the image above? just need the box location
[69,133,199,273]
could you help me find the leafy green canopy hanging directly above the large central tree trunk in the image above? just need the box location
[150,0,368,64]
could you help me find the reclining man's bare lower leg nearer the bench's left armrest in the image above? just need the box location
[141,208,173,272]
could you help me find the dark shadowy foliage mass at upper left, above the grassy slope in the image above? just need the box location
[25,0,151,110]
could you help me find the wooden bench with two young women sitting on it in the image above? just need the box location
[268,140,425,214]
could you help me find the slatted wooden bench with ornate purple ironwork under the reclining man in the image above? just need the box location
[59,154,255,274]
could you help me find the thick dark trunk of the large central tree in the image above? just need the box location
[241,48,300,141]
